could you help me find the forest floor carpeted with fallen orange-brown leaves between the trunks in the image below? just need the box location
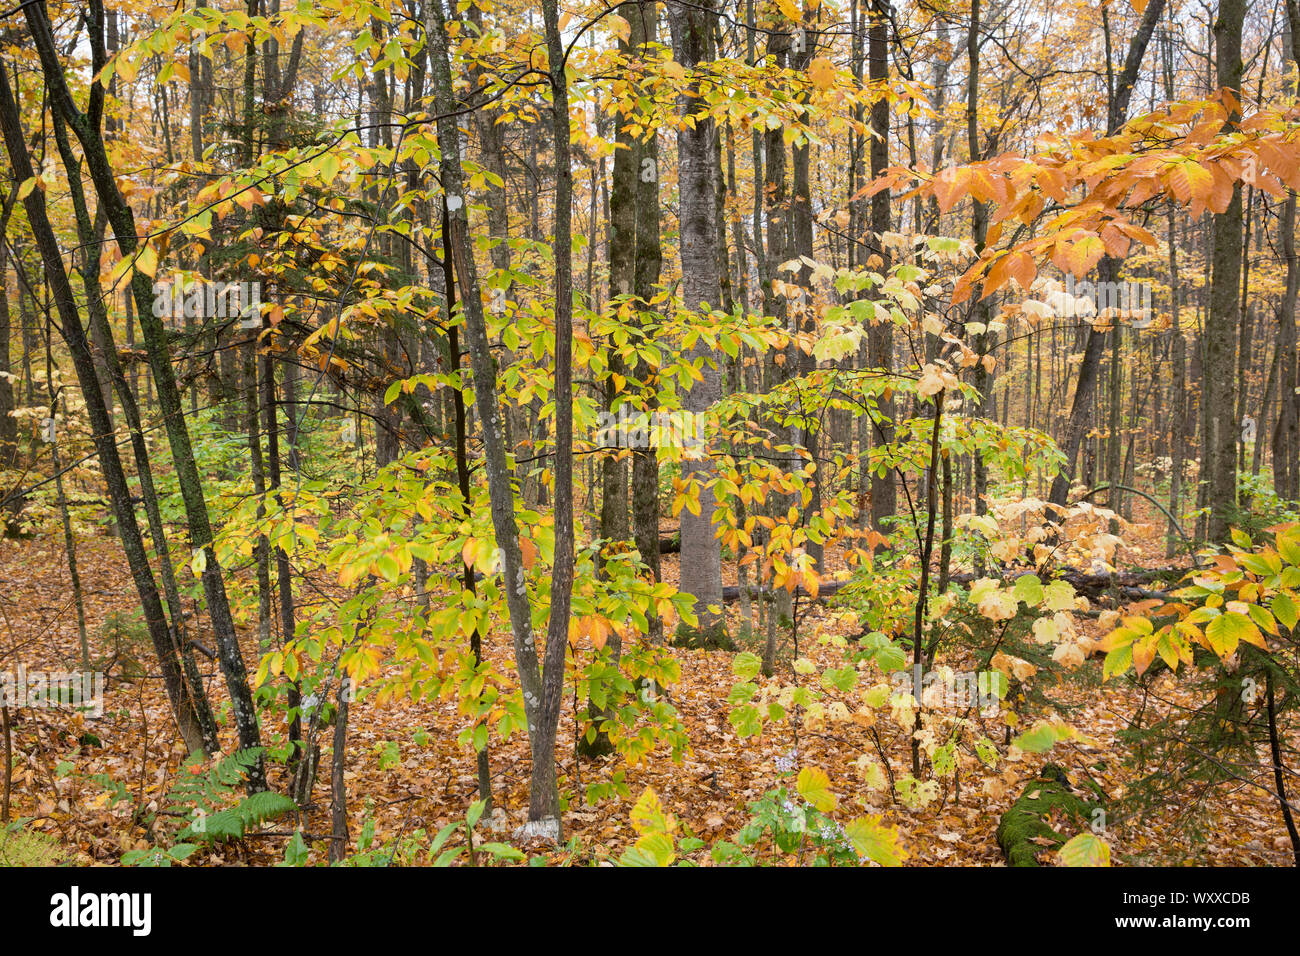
[0,502,1300,866]
